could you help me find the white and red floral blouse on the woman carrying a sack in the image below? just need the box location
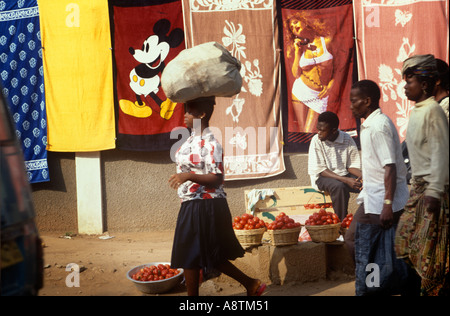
[175,129,226,202]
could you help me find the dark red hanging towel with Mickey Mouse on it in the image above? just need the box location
[109,0,185,151]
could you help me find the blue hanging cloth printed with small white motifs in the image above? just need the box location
[0,0,50,183]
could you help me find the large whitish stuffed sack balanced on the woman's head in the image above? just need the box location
[161,42,242,102]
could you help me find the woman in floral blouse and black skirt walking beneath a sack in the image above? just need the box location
[169,97,266,296]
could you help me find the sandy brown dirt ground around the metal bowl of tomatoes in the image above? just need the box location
[39,231,355,296]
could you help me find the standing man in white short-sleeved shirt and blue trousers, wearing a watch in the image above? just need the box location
[345,80,409,295]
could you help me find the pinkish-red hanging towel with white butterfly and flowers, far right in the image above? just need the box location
[353,0,449,141]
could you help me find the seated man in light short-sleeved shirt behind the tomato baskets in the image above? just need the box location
[308,111,362,221]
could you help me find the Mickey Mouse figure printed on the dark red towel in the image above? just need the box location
[119,19,184,120]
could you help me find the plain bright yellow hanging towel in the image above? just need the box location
[39,0,115,152]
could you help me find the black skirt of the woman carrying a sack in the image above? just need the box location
[171,198,245,272]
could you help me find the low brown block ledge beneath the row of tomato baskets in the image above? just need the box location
[219,242,355,285]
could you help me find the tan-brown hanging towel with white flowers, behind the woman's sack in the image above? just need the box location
[183,0,285,180]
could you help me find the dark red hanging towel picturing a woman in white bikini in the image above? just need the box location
[280,0,356,152]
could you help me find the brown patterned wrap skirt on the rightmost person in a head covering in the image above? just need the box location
[395,178,450,296]
